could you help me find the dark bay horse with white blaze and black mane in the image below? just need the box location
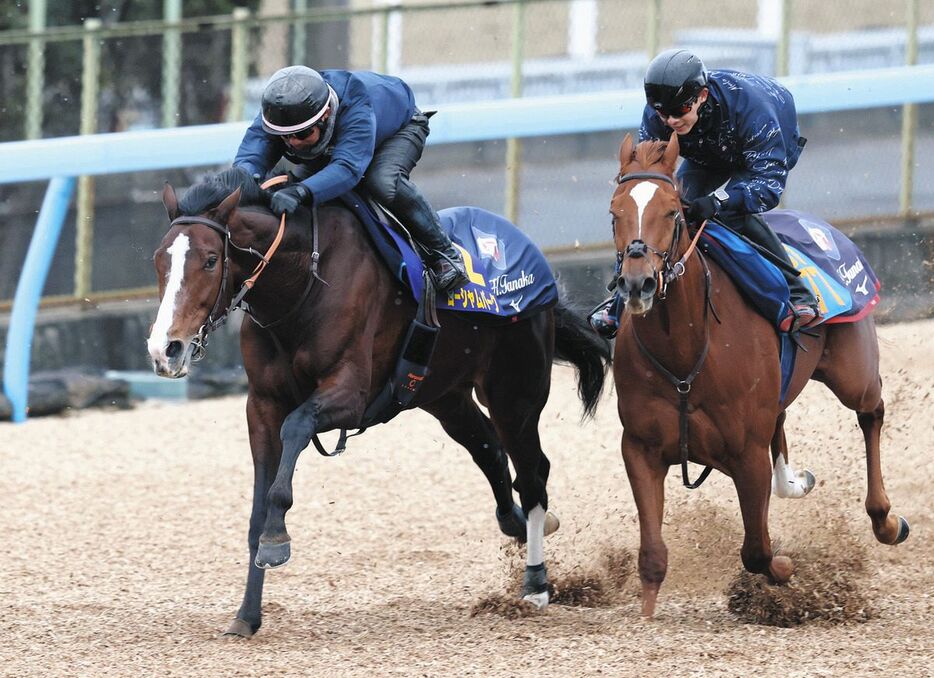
[148,169,609,637]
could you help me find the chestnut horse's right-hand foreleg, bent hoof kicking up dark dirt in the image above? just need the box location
[730,448,794,583]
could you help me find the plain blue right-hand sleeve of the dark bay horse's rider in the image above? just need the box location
[302,78,376,202]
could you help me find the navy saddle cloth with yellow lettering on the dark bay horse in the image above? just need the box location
[340,192,558,319]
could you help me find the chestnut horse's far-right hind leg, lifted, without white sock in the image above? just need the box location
[818,316,909,544]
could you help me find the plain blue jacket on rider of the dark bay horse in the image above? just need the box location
[234,70,416,202]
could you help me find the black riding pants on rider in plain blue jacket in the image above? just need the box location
[363,111,451,251]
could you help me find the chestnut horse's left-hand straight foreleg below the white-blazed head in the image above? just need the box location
[622,432,668,617]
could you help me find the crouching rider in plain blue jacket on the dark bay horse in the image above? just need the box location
[233,66,468,292]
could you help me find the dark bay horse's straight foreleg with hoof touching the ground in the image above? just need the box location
[226,397,282,638]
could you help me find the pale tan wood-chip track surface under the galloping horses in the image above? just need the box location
[0,321,934,676]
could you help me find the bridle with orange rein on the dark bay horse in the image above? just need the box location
[170,209,327,362]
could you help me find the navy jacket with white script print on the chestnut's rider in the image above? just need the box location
[639,70,804,213]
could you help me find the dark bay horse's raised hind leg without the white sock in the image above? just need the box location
[423,388,526,541]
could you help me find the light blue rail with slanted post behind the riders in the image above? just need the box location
[0,65,934,422]
